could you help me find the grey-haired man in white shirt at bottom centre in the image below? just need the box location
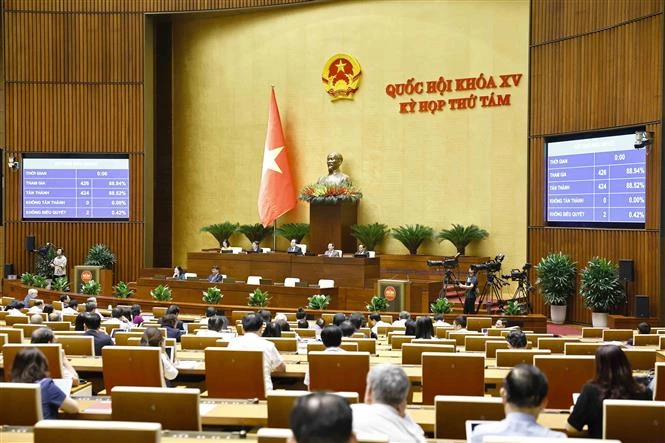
[351,364,426,443]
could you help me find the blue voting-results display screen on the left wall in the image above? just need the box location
[21,154,129,220]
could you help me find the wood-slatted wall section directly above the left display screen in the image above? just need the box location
[5,83,143,152]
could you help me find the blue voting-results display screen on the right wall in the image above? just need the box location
[547,133,646,227]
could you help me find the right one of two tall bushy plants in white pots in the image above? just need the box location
[580,257,626,327]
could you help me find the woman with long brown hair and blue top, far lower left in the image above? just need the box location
[6,348,79,420]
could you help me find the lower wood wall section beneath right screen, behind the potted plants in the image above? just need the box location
[528,227,661,323]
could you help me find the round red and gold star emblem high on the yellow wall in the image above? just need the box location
[321,54,362,101]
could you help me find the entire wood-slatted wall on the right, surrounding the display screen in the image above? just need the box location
[527,0,665,323]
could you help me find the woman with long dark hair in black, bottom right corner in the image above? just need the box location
[567,345,653,438]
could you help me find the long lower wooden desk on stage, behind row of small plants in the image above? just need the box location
[135,278,346,309]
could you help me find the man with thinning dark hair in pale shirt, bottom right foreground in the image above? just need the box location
[470,365,566,443]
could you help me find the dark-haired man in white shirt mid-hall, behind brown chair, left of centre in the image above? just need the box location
[228,314,286,392]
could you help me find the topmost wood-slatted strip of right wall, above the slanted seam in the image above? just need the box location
[531,0,663,45]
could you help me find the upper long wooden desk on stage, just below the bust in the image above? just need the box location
[187,252,379,290]
